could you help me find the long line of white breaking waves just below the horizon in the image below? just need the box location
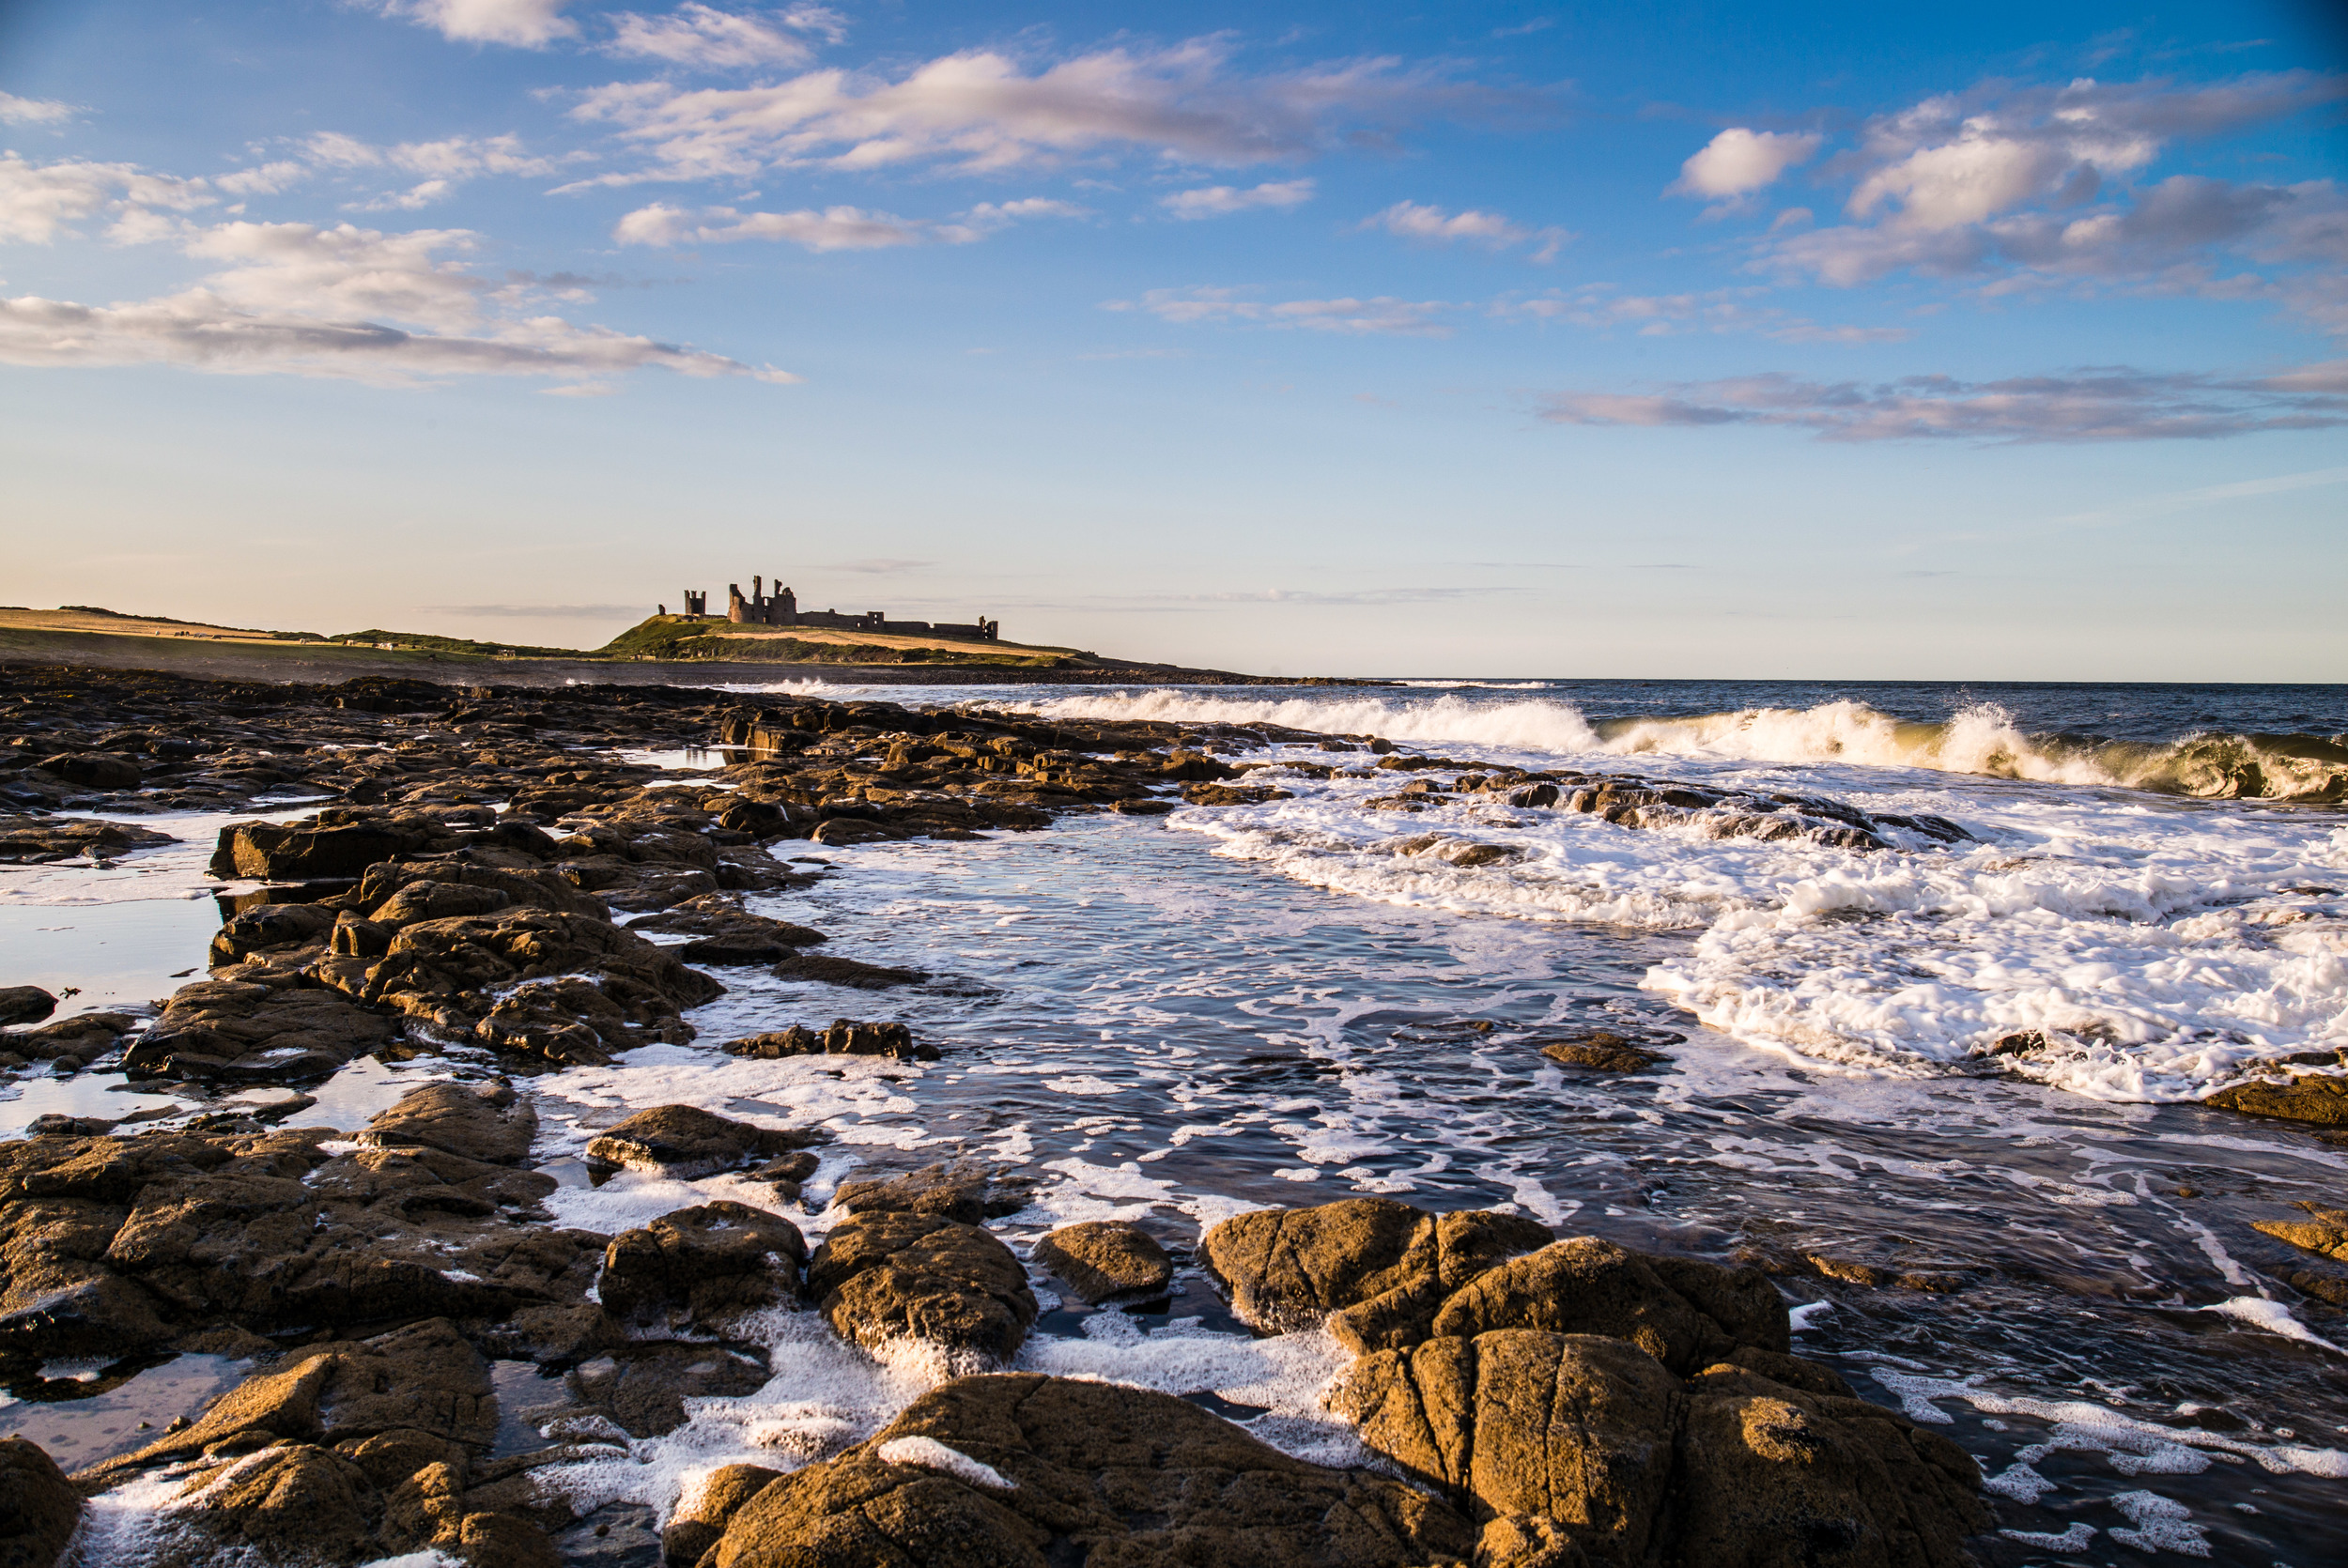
[1014,690,2348,803]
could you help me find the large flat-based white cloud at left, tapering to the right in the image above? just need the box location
[0,223,796,385]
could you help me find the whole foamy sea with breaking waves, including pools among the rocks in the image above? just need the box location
[0,679,2348,1568]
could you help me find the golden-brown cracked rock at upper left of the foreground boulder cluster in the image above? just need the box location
[1200,1197,1550,1350]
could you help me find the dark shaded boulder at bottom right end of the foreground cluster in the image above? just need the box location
[1670,1366,1991,1568]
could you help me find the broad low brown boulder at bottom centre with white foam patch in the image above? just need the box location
[709,1374,1475,1568]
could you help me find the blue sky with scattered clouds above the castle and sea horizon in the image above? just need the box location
[0,0,2348,681]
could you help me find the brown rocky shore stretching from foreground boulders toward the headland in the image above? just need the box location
[0,669,2348,1568]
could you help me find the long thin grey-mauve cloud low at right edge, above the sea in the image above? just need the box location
[1538,366,2348,444]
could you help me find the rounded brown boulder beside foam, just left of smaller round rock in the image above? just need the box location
[808,1214,1036,1364]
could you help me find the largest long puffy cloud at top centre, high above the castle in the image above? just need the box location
[571,40,1501,183]
